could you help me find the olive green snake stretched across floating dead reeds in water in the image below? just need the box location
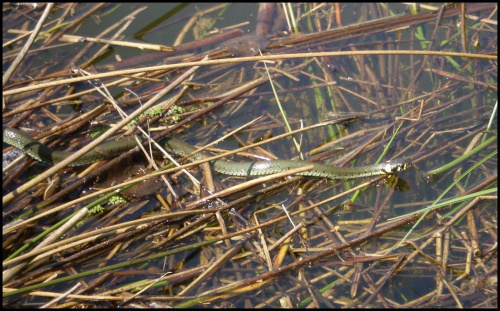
[3,127,411,179]
